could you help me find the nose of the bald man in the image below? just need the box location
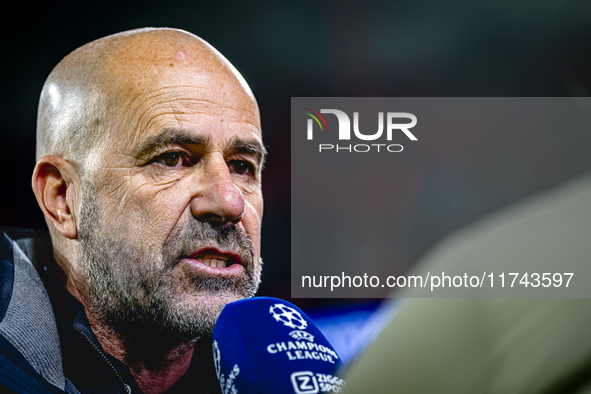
[191,160,244,225]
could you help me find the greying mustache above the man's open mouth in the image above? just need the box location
[163,220,254,269]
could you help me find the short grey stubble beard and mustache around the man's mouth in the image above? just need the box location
[79,184,262,342]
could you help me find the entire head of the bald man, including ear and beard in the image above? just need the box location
[33,29,265,339]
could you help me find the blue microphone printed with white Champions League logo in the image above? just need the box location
[213,297,345,394]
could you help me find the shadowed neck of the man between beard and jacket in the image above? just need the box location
[88,316,197,394]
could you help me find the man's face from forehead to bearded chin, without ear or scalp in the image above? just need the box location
[79,56,264,337]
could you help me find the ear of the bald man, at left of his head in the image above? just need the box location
[32,155,80,239]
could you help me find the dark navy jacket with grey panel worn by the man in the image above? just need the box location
[0,228,220,394]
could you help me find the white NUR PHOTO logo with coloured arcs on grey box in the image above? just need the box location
[302,107,417,153]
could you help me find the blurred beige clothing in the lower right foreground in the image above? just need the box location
[345,176,591,394]
